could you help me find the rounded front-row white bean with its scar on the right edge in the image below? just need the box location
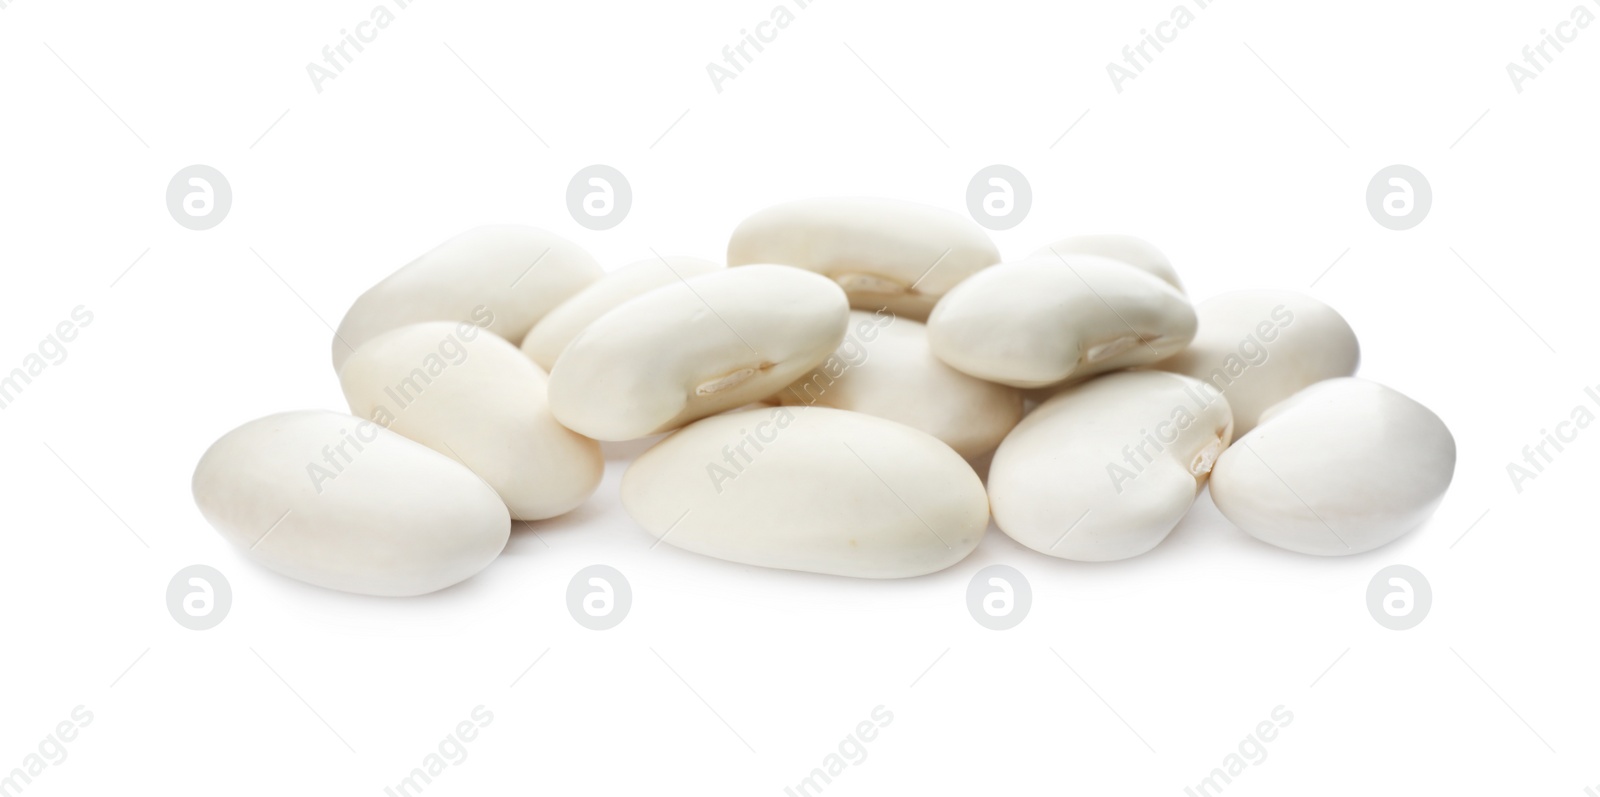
[989,371,1232,562]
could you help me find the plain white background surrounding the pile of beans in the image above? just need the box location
[0,0,1600,797]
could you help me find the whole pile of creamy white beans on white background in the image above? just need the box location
[194,198,1456,595]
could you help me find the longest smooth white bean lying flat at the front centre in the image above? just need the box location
[622,407,989,578]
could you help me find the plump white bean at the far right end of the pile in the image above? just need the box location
[1211,378,1456,555]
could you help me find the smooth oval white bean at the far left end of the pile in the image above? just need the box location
[194,410,510,595]
